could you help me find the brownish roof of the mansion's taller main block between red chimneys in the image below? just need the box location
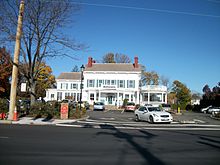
[85,63,141,72]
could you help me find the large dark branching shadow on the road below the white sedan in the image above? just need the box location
[97,124,165,165]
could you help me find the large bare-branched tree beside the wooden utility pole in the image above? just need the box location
[0,0,86,103]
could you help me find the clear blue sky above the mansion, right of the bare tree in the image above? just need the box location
[48,0,220,93]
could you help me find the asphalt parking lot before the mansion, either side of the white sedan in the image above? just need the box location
[88,110,220,125]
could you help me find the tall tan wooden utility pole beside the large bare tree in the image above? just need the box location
[8,0,24,120]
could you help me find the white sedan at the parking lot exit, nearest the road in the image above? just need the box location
[134,107,173,123]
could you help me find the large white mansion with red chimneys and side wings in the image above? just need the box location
[44,57,167,106]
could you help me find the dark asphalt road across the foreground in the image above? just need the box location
[0,125,220,165]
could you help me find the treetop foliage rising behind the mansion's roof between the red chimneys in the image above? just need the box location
[102,53,131,63]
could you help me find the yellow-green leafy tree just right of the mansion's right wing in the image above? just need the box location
[172,80,191,109]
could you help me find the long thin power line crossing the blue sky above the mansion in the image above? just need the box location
[68,1,220,18]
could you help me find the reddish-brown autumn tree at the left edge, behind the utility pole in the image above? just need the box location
[0,47,12,98]
